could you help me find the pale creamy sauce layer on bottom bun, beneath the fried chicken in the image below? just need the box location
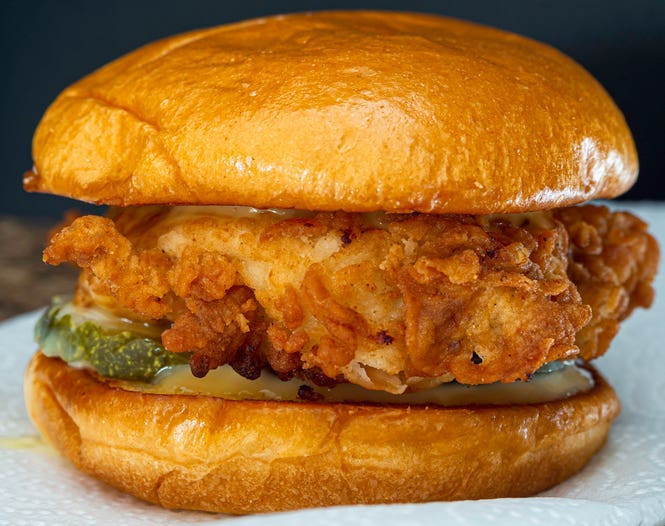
[115,363,594,406]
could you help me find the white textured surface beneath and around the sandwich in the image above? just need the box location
[0,204,665,526]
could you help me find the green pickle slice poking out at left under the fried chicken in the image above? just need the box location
[35,298,190,382]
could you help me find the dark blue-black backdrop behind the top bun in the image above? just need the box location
[0,0,665,217]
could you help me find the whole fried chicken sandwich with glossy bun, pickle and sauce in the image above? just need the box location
[25,12,658,514]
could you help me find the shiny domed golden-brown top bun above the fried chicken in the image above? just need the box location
[25,12,638,214]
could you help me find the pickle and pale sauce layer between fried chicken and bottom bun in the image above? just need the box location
[35,297,594,406]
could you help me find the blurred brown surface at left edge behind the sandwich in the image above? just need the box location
[0,216,78,319]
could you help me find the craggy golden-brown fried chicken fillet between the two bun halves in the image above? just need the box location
[45,207,658,393]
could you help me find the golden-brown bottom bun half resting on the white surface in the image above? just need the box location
[25,353,619,513]
